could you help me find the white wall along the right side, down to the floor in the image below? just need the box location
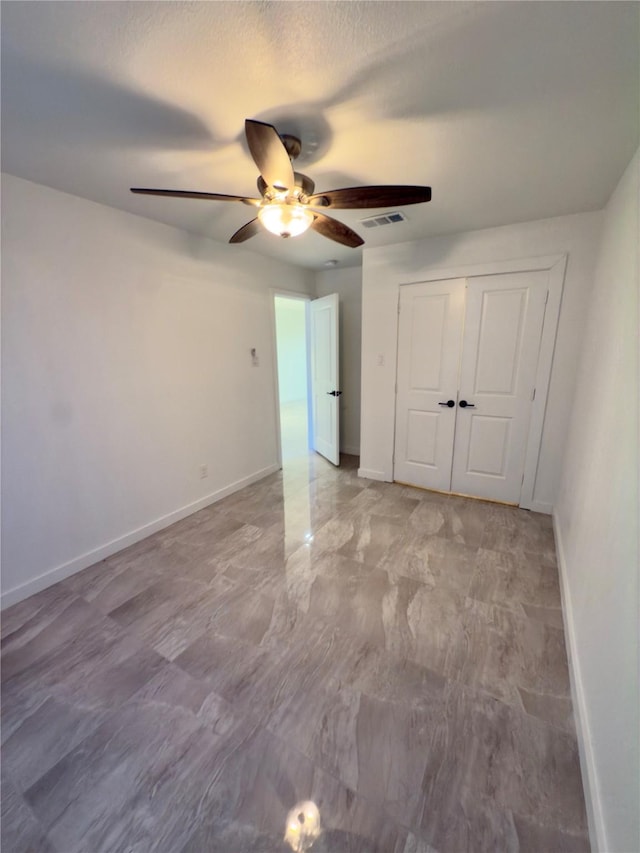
[554,152,640,853]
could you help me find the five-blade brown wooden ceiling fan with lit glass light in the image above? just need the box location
[131,119,431,248]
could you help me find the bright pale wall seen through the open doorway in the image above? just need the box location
[274,296,308,403]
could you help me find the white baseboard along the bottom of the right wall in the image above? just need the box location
[552,507,608,853]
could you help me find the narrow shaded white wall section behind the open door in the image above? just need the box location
[316,267,362,456]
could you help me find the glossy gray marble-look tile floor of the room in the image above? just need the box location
[2,456,589,853]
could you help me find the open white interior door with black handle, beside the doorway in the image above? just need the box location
[310,293,342,465]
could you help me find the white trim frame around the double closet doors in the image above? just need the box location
[392,254,567,512]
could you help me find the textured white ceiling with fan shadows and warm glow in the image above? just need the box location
[2,0,640,268]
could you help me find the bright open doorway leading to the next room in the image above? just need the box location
[274,294,313,462]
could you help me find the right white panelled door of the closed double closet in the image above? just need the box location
[451,271,548,503]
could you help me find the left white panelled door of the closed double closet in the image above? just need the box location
[394,279,465,490]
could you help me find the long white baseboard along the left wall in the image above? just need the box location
[0,464,280,610]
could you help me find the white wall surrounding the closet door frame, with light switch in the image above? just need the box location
[360,213,602,512]
